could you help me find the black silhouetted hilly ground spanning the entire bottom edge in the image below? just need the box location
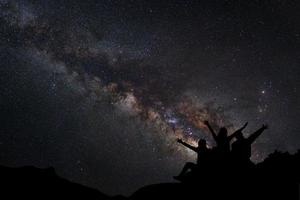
[0,151,300,200]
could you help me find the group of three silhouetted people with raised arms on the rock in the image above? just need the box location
[174,121,268,179]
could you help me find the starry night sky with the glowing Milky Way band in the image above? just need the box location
[0,0,300,195]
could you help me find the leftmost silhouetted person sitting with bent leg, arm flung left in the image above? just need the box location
[174,139,210,180]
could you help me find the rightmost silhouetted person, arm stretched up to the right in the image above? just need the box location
[231,124,268,164]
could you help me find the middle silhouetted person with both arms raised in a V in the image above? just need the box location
[204,121,248,154]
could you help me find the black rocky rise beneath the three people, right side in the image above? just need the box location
[131,152,300,200]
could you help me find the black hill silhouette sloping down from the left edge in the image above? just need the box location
[0,166,122,200]
